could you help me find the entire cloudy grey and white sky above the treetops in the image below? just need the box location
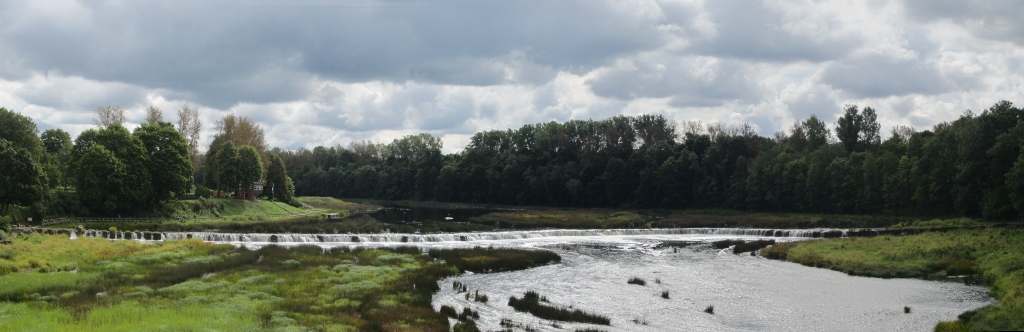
[0,0,1024,153]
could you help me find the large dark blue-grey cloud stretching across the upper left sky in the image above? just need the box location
[0,0,663,108]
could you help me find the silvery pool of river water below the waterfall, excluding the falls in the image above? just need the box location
[433,239,991,331]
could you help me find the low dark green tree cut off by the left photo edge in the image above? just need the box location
[0,139,44,216]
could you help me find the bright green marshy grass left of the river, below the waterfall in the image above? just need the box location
[0,234,557,331]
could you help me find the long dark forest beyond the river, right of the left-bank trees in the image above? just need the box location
[273,101,1024,219]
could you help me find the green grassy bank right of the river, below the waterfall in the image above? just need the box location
[761,225,1024,331]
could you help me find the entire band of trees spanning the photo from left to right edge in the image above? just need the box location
[0,101,1024,219]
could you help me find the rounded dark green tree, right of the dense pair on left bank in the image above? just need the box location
[132,122,193,201]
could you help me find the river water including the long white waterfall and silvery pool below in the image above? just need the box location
[72,229,993,331]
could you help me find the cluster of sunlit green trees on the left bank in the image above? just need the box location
[0,105,294,220]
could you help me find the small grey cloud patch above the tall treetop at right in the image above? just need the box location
[822,55,951,97]
